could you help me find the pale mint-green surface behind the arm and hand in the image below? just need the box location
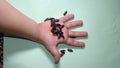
[4,0,120,68]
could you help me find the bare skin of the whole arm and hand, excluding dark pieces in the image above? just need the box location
[0,0,88,64]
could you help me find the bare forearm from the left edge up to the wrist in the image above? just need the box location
[0,0,39,41]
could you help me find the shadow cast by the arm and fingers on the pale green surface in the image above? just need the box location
[4,36,87,68]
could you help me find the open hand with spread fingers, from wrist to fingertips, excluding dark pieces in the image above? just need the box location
[39,14,87,63]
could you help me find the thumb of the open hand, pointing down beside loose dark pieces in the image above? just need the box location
[47,46,60,64]
